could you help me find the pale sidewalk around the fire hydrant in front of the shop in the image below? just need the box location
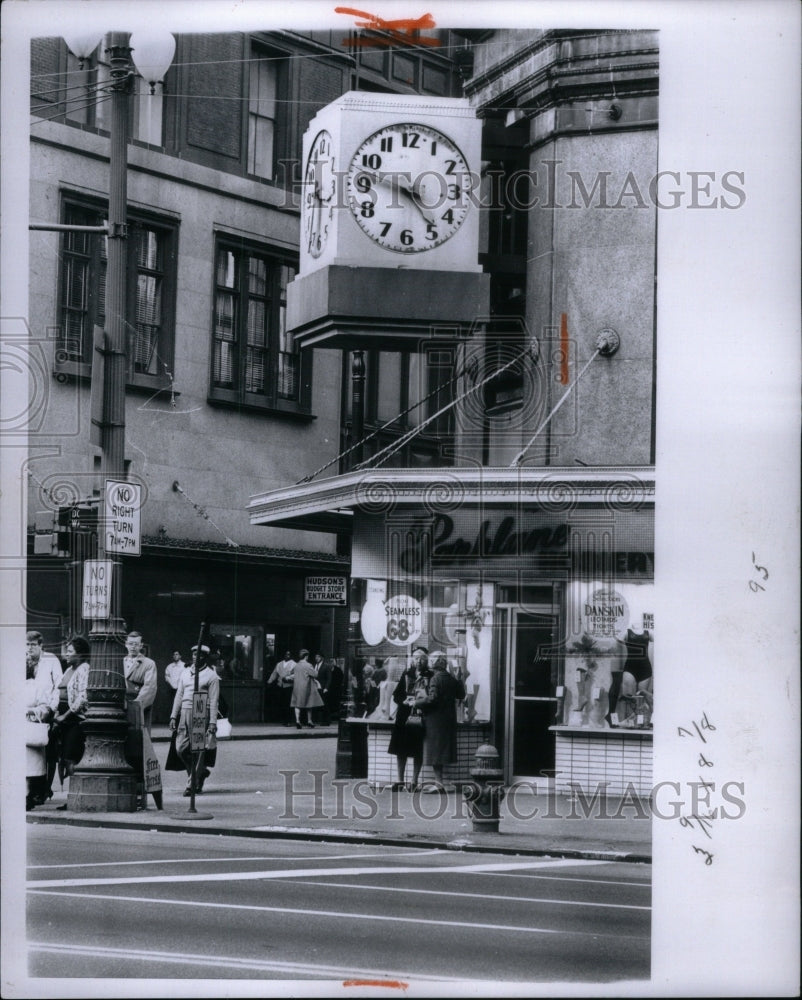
[27,724,652,862]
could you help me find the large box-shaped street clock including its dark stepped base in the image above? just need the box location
[287,91,489,351]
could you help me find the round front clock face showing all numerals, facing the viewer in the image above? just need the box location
[348,122,471,253]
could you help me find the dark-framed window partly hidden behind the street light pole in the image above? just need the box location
[55,201,177,389]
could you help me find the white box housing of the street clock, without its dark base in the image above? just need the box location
[299,91,481,275]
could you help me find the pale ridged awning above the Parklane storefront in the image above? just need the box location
[247,466,655,532]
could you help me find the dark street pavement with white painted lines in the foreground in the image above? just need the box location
[25,824,651,984]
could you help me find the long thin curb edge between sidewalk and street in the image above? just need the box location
[26,813,652,865]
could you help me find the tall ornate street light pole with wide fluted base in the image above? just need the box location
[67,32,136,812]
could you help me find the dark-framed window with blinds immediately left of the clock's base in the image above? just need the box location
[209,238,311,414]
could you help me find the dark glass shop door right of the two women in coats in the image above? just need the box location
[507,607,557,779]
